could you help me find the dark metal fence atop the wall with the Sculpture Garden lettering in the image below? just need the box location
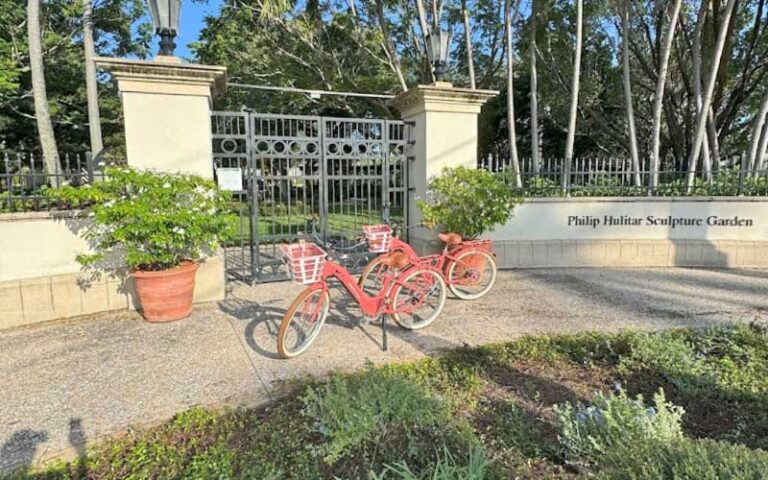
[480,156,768,197]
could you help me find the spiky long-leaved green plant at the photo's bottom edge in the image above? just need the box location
[372,445,490,480]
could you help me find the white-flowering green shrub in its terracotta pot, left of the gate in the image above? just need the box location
[47,167,232,322]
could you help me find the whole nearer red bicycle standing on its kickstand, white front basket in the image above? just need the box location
[277,238,447,358]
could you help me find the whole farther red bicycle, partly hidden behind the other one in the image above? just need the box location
[358,229,497,300]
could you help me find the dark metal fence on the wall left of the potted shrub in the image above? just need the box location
[0,152,103,213]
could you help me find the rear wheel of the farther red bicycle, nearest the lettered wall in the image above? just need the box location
[445,250,496,300]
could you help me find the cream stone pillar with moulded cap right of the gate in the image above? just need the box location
[392,82,499,253]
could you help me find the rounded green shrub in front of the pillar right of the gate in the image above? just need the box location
[418,167,520,238]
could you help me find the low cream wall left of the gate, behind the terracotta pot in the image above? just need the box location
[0,212,225,329]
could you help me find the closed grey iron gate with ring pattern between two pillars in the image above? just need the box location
[211,112,408,282]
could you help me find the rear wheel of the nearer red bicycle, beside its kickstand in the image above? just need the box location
[391,267,447,330]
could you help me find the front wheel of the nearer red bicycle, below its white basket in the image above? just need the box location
[277,288,331,358]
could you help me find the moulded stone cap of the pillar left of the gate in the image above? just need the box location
[94,57,227,95]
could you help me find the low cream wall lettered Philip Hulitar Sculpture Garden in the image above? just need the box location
[411,197,768,268]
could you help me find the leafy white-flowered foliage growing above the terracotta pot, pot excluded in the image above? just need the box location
[45,167,233,270]
